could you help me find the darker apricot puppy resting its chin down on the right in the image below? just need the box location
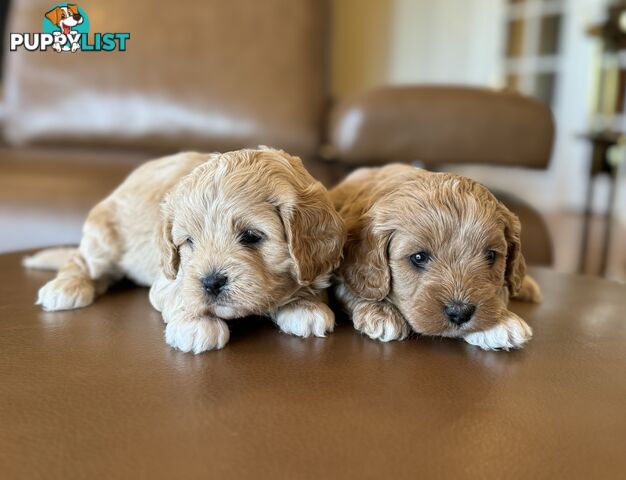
[331,165,540,350]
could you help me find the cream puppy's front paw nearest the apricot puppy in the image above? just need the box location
[275,302,335,337]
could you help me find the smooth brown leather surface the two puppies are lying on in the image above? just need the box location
[0,255,626,479]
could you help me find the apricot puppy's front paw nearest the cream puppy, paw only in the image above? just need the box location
[352,302,411,342]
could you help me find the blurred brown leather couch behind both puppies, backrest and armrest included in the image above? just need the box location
[0,0,554,264]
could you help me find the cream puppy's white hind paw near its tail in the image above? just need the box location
[36,278,96,312]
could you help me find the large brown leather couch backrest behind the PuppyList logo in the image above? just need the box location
[4,0,327,155]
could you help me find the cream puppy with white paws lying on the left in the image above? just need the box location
[24,148,345,353]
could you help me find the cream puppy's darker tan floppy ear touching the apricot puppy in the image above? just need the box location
[278,182,346,285]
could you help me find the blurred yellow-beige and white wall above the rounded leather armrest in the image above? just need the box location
[332,0,503,96]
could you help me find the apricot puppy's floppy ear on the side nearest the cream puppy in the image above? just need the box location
[339,212,390,301]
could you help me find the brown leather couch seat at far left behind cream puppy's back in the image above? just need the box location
[0,147,144,252]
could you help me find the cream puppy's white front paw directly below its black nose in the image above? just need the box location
[165,318,230,353]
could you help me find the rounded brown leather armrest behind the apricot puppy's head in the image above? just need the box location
[328,86,554,168]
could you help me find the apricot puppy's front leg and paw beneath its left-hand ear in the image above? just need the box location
[336,285,411,342]
